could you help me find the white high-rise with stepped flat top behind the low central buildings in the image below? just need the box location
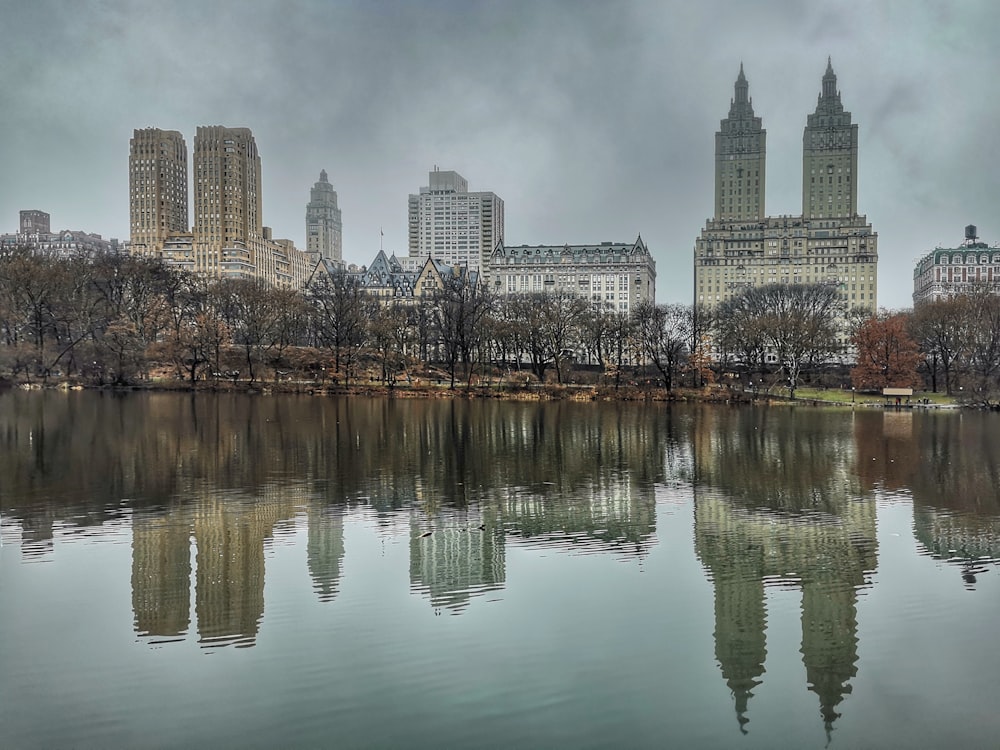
[409,168,503,275]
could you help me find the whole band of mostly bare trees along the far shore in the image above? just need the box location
[0,249,1000,403]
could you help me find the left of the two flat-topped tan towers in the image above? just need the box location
[129,128,188,255]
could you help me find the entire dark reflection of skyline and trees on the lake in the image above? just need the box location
[0,393,1000,744]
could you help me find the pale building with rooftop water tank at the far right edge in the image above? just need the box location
[913,224,1000,305]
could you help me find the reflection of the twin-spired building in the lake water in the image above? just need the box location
[692,409,877,734]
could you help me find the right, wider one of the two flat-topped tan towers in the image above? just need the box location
[194,125,264,276]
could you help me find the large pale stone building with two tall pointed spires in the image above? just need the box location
[694,61,878,350]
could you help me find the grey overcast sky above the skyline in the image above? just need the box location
[0,0,1000,308]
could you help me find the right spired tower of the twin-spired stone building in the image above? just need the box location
[802,58,858,219]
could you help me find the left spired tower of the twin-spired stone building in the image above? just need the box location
[715,63,767,221]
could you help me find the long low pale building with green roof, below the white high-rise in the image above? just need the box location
[489,236,656,313]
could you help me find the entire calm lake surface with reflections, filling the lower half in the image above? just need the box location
[0,391,1000,748]
